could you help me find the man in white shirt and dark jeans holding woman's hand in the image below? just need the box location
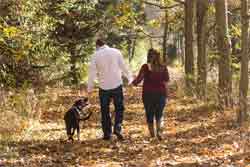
[88,39,132,140]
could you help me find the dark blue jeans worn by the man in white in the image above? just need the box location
[99,86,124,137]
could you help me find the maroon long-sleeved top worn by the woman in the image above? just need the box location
[132,64,169,96]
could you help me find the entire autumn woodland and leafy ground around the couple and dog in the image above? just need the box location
[0,0,250,167]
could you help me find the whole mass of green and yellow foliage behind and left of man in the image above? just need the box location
[0,0,150,88]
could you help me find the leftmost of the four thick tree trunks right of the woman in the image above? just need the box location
[185,0,196,95]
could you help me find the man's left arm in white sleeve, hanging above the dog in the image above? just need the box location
[87,56,97,93]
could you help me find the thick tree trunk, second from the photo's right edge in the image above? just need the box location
[215,0,232,106]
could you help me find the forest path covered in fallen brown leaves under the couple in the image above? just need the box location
[0,67,250,167]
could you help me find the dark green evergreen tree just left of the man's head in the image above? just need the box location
[44,1,102,85]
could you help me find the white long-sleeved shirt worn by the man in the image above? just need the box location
[88,45,132,92]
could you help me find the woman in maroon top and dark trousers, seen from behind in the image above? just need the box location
[132,49,169,140]
